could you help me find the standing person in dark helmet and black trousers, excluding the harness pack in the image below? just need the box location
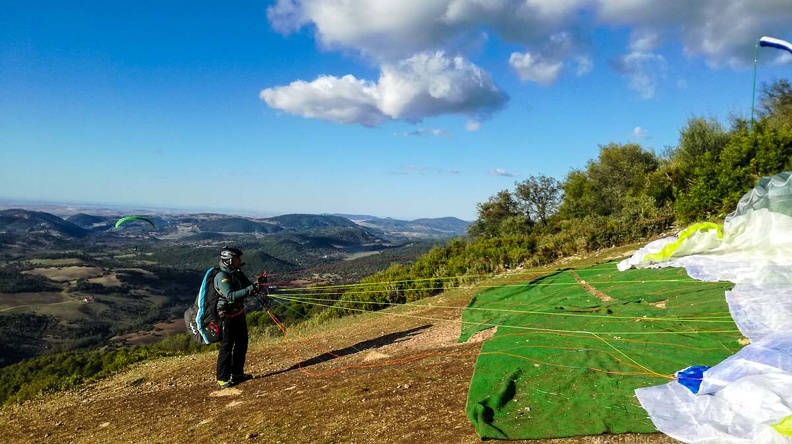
[214,247,261,388]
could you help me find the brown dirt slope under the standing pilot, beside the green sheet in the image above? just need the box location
[0,256,676,444]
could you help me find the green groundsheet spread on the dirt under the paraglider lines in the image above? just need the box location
[459,262,742,439]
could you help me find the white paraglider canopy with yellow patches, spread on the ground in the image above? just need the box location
[618,172,792,443]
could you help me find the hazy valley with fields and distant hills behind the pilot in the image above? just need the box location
[0,209,464,366]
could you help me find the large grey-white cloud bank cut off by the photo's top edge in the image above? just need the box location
[267,0,792,66]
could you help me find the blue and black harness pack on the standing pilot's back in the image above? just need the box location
[184,267,222,345]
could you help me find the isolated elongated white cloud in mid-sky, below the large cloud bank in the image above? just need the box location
[260,51,508,126]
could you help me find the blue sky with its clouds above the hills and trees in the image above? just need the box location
[0,0,792,220]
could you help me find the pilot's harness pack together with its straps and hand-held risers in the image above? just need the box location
[184,266,270,345]
